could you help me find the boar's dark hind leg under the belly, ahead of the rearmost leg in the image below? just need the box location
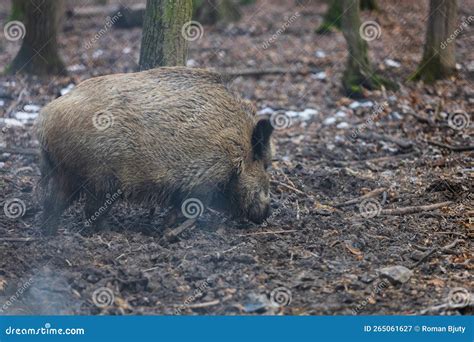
[84,189,115,229]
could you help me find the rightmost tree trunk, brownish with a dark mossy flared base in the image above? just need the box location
[411,0,458,82]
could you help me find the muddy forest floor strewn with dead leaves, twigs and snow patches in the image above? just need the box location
[0,0,474,315]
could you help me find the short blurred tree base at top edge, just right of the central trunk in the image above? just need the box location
[193,0,241,25]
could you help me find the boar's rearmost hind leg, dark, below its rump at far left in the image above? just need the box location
[41,172,79,235]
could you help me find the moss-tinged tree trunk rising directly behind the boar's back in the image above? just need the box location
[139,0,192,70]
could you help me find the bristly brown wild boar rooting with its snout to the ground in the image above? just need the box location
[37,67,273,234]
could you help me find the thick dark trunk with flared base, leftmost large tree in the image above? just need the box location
[7,0,66,75]
